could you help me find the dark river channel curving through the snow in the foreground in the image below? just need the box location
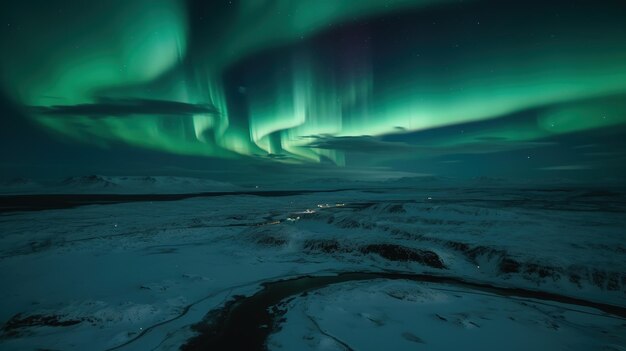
[181,272,626,351]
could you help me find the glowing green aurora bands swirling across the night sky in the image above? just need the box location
[0,0,626,170]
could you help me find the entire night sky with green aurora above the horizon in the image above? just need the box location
[0,0,626,182]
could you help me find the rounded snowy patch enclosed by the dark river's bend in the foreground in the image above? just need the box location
[268,280,626,351]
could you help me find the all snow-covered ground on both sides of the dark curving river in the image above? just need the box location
[0,187,626,350]
